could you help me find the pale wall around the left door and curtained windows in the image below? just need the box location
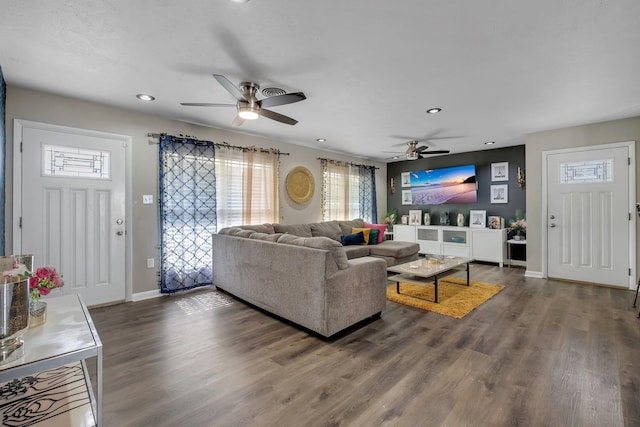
[5,86,387,294]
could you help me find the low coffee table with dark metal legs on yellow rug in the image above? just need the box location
[387,256,473,303]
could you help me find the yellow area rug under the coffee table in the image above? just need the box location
[387,277,504,319]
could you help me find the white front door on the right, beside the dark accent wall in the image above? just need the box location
[546,144,632,287]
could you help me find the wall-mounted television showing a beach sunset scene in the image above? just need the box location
[410,165,478,205]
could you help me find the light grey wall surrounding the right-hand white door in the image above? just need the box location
[525,117,640,280]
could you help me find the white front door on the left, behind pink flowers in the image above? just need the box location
[14,123,127,305]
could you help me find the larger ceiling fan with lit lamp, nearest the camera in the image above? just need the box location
[180,74,307,126]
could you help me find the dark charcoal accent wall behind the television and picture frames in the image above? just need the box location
[387,145,526,225]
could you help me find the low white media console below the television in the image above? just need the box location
[393,224,507,267]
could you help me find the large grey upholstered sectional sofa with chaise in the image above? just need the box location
[212,219,419,337]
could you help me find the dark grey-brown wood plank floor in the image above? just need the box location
[91,264,640,427]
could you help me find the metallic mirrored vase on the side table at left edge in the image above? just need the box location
[0,276,29,364]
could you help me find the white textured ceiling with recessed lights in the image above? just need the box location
[0,0,640,161]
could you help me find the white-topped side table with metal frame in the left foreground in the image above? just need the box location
[0,294,102,426]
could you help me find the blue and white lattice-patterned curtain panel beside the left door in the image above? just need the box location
[159,135,217,293]
